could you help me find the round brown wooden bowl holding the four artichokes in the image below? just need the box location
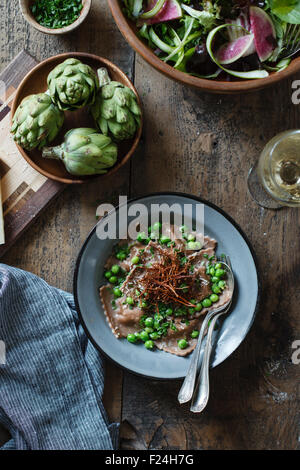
[11,52,142,183]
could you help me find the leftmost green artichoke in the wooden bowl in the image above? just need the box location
[11,93,64,150]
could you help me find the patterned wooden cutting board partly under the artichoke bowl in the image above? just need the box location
[0,51,65,257]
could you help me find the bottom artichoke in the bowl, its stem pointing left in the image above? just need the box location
[43,127,118,176]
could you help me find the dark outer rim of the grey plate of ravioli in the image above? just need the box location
[73,191,261,381]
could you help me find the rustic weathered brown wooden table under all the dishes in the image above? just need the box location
[0,0,300,449]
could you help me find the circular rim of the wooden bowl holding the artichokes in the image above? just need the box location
[10,52,143,184]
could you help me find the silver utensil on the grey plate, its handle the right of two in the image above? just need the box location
[190,257,234,413]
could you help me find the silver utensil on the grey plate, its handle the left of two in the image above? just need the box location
[178,262,233,404]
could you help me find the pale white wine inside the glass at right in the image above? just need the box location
[257,130,300,207]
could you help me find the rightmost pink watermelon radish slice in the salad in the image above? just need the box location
[249,7,277,62]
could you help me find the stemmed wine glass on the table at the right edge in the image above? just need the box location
[248,129,300,209]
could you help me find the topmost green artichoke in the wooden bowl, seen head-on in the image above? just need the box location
[48,59,99,111]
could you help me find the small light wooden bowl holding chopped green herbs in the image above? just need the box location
[19,0,92,35]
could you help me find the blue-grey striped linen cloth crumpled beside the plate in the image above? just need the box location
[0,264,118,450]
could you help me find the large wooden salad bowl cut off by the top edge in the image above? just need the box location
[108,0,300,94]
